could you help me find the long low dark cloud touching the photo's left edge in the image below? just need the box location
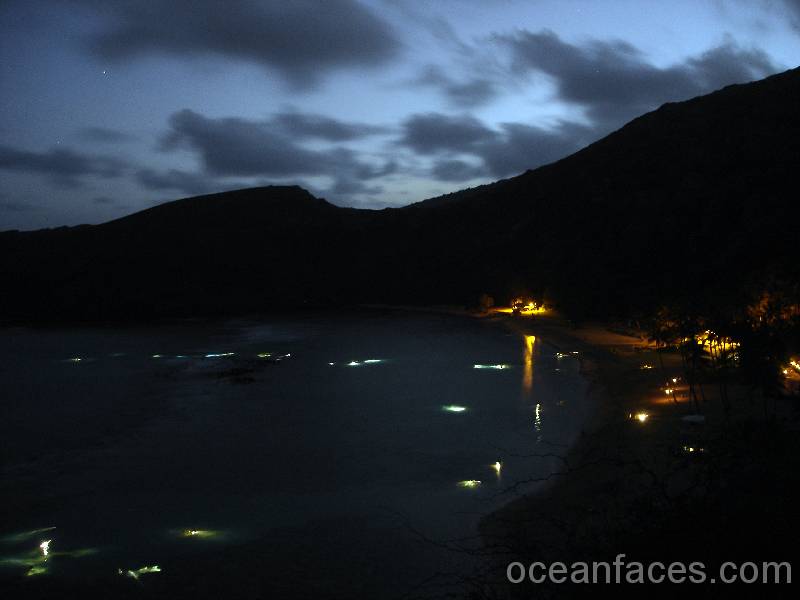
[0,145,126,187]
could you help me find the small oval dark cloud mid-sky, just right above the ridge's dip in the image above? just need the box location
[400,113,496,154]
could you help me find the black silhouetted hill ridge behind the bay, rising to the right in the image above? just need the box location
[0,69,800,319]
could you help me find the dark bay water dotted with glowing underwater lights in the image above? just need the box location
[0,313,586,598]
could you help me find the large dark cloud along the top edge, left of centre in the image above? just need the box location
[85,0,400,87]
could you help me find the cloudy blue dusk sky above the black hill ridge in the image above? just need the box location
[0,0,800,230]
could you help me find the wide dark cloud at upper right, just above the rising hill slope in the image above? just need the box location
[504,30,777,131]
